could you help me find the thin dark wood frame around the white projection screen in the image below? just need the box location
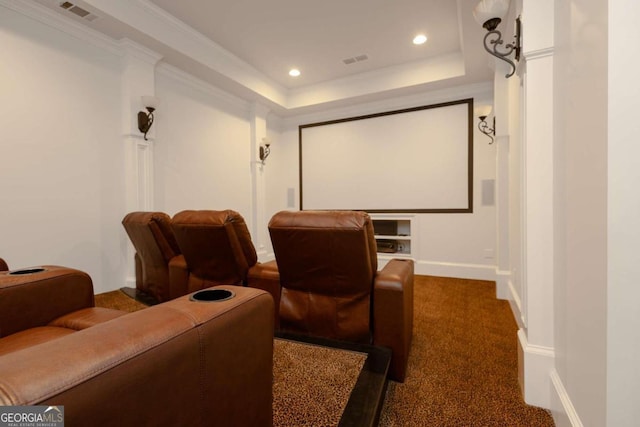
[298,98,473,213]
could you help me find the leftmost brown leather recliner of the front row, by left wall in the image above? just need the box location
[122,212,189,302]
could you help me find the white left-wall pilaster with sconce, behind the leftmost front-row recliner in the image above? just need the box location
[121,39,162,287]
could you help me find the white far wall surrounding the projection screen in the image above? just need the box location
[267,85,496,280]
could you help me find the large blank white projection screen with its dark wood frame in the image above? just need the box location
[298,99,473,213]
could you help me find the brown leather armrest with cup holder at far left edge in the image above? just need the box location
[0,265,94,337]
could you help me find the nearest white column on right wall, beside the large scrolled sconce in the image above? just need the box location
[518,0,555,408]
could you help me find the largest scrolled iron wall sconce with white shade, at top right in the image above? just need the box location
[473,0,521,78]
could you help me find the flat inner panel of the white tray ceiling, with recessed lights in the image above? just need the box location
[152,0,461,88]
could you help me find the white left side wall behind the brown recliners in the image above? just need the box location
[0,4,266,293]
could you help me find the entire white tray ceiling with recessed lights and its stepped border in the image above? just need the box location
[35,0,493,115]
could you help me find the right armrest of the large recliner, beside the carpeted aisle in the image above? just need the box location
[373,259,414,382]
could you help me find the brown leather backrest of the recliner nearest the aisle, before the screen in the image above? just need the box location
[269,211,377,342]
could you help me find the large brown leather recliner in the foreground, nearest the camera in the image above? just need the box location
[0,266,273,426]
